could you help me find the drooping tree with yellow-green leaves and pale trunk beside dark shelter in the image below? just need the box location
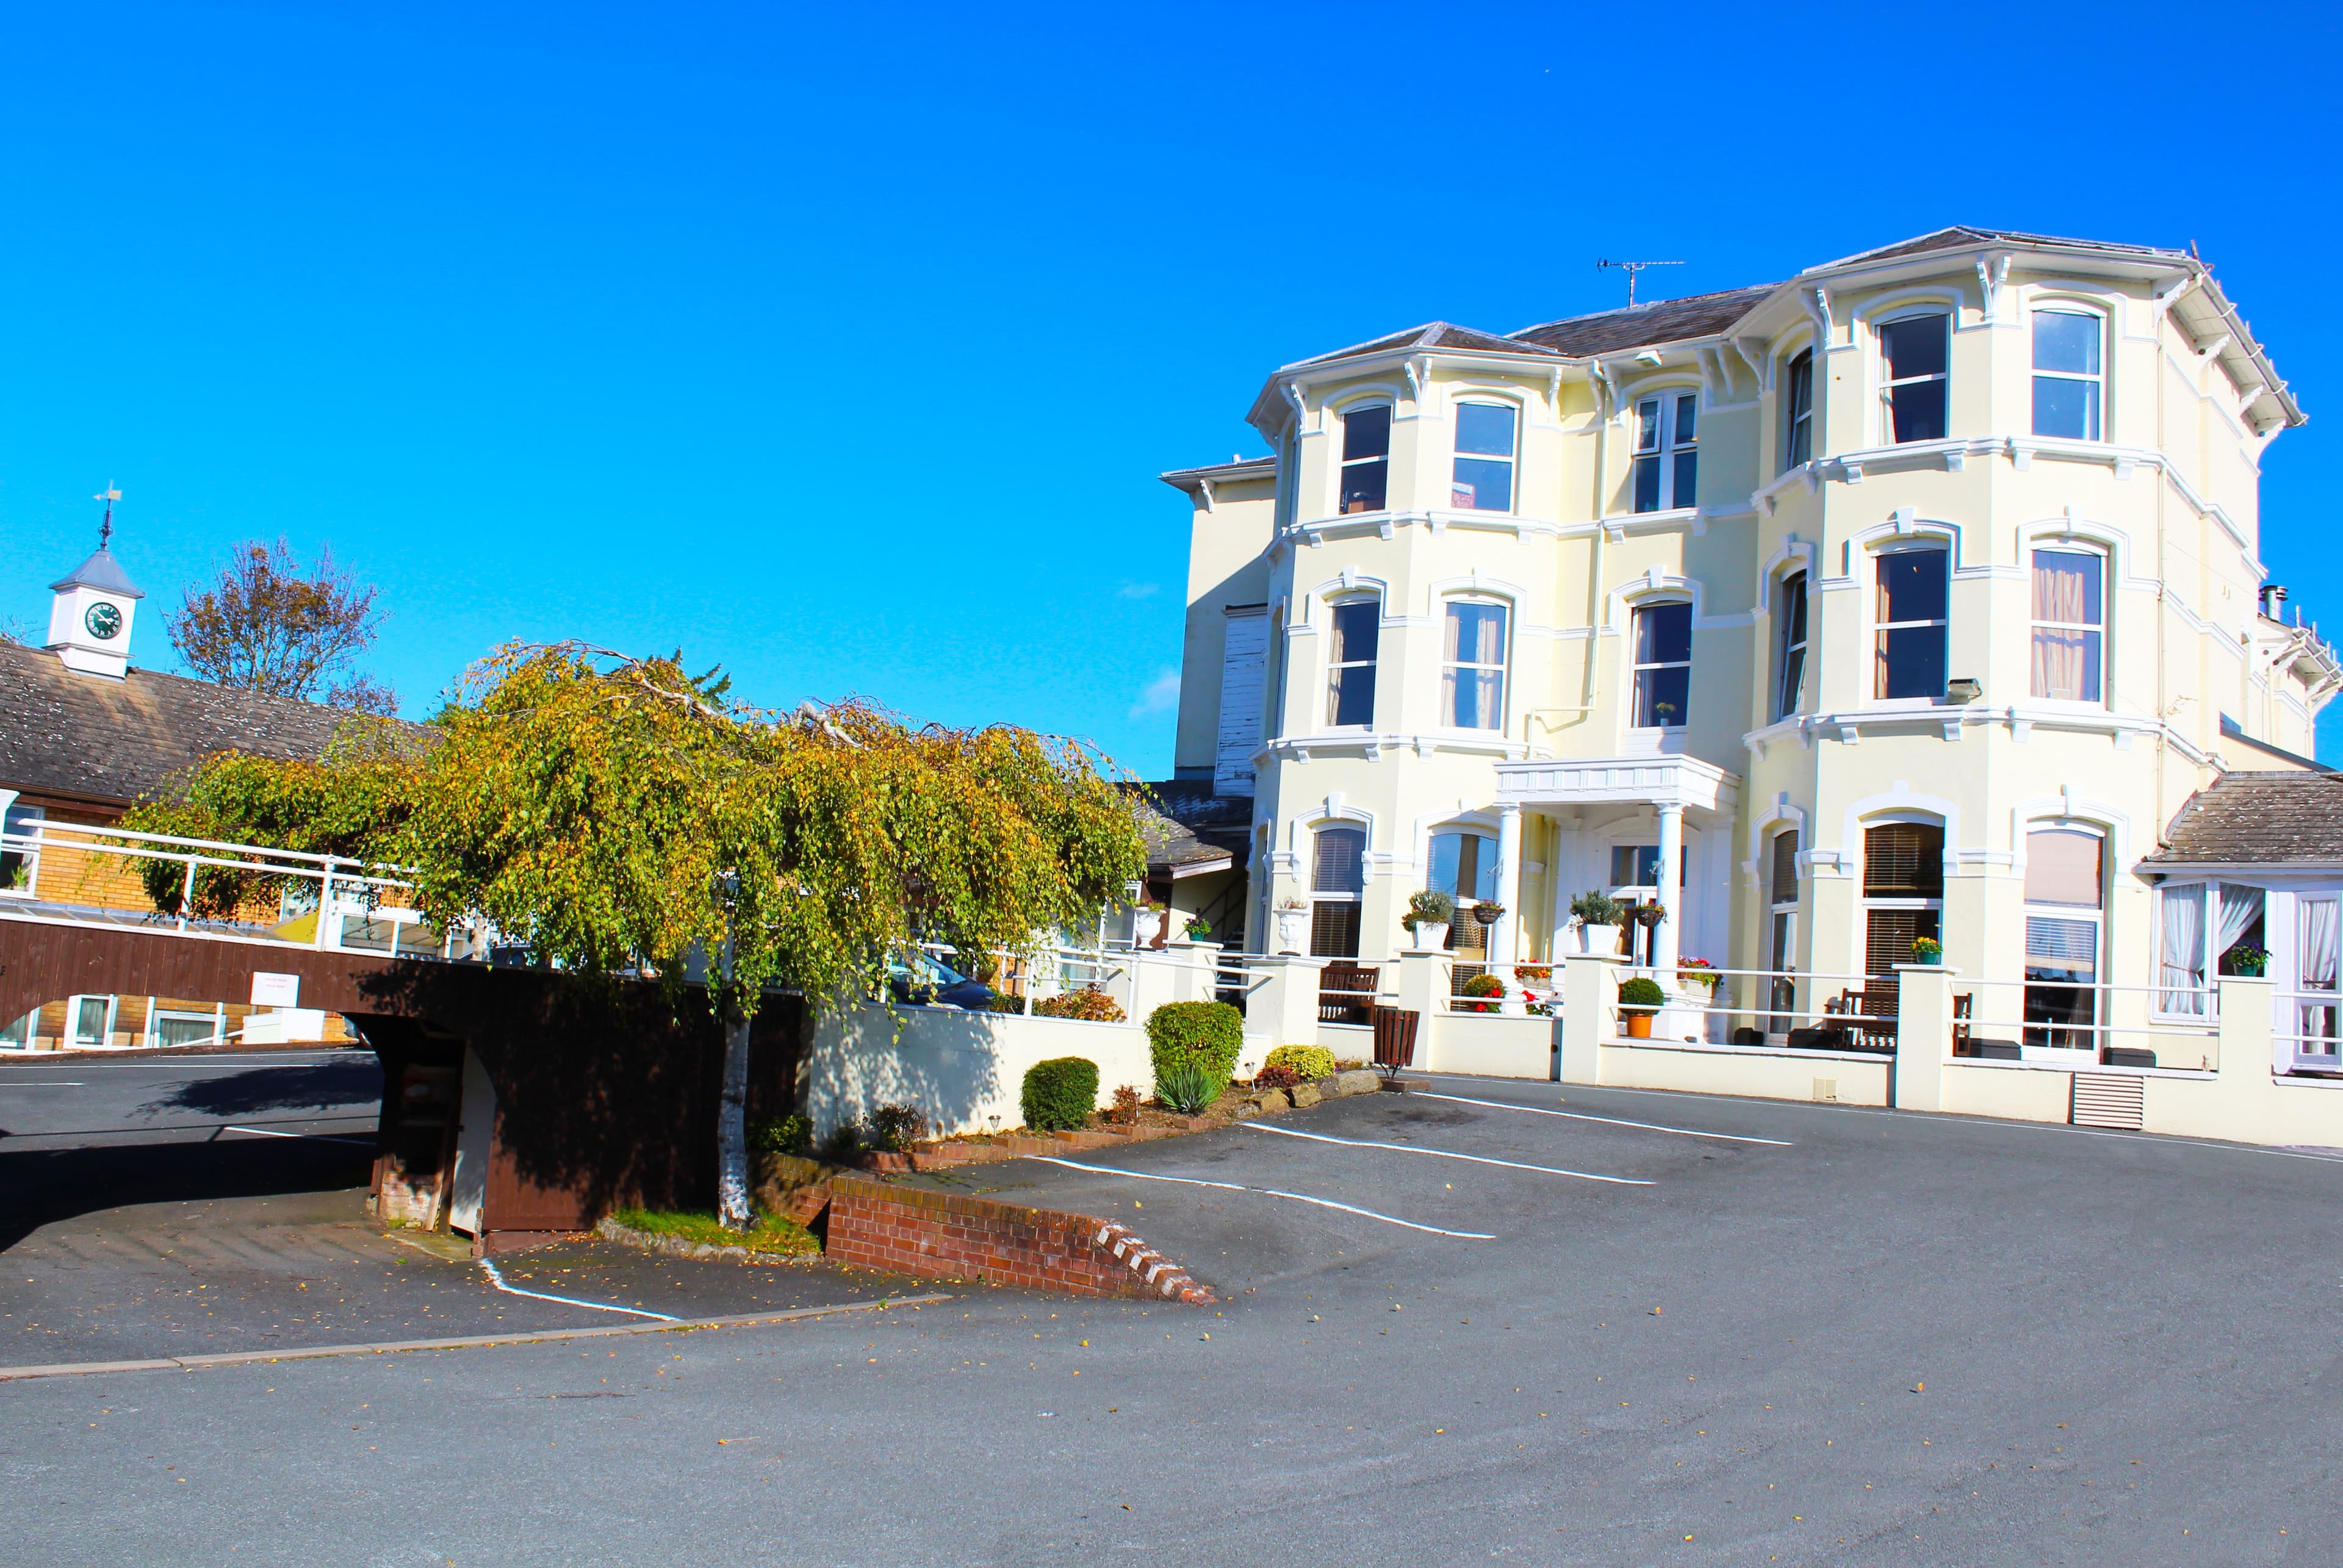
[126,642,1146,1228]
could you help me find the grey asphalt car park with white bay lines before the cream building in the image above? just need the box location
[0,1078,2343,1566]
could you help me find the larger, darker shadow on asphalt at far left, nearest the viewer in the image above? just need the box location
[0,1139,373,1251]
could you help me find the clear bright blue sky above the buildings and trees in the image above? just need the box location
[0,2,2343,776]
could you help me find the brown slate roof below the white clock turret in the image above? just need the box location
[0,644,398,806]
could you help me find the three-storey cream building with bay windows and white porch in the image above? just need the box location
[1164,228,2343,1055]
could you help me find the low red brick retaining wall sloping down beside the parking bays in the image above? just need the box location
[822,1176,1214,1303]
